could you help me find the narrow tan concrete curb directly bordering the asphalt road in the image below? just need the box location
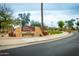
[0,33,73,51]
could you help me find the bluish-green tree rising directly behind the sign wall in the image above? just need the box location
[19,13,30,27]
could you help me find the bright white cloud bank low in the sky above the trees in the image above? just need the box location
[14,10,79,26]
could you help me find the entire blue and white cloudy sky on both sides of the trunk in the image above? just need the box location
[4,3,79,26]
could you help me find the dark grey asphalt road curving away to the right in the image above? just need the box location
[0,33,79,56]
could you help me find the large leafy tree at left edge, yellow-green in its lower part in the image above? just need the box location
[0,4,12,31]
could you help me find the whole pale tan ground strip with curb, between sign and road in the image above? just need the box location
[0,32,73,50]
